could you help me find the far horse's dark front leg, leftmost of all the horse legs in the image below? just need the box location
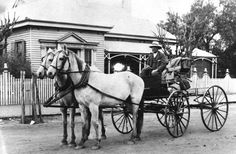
[60,108,68,145]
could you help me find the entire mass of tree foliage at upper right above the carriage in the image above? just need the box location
[158,0,236,76]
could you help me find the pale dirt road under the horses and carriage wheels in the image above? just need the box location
[0,104,236,154]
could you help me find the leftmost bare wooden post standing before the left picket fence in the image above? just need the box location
[20,71,25,124]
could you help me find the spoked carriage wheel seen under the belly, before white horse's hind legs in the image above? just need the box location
[111,107,133,134]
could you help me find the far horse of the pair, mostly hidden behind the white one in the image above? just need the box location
[36,49,106,146]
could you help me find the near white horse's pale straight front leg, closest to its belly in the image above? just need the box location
[89,104,102,150]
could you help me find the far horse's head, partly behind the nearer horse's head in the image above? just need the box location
[36,48,55,79]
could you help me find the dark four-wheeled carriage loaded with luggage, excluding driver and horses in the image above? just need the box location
[111,58,228,137]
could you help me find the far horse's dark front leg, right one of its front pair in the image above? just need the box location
[69,108,76,147]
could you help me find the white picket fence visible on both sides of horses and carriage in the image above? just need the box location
[0,65,236,106]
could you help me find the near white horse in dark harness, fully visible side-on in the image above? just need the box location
[47,50,144,149]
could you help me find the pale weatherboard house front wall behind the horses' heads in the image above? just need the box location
[8,27,105,71]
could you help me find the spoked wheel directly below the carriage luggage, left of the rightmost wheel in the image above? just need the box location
[165,90,190,137]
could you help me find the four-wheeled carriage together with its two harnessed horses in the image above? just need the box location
[38,49,228,149]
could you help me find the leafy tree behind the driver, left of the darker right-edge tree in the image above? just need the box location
[159,0,218,56]
